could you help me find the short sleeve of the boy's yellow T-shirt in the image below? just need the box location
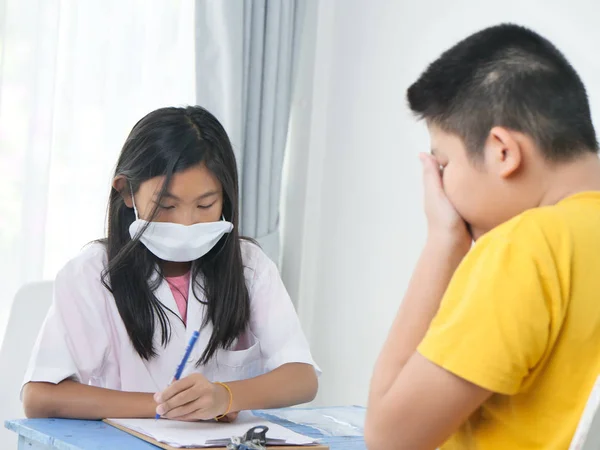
[418,229,560,395]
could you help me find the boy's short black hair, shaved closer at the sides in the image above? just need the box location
[407,24,598,161]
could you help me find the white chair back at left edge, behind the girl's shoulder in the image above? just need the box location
[0,281,53,448]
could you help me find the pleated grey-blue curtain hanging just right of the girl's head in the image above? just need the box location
[195,0,301,262]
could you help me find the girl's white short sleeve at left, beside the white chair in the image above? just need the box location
[23,244,109,384]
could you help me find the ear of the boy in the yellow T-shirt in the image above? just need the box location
[486,127,523,178]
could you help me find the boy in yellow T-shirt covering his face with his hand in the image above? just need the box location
[365,25,600,450]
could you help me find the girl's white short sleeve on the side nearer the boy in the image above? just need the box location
[245,248,320,374]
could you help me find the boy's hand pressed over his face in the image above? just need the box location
[419,153,472,253]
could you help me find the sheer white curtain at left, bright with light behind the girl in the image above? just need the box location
[0,0,196,340]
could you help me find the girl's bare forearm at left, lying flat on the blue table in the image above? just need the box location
[23,380,156,420]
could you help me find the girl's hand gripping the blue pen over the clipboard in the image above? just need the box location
[154,373,231,421]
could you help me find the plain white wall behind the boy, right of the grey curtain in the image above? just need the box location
[282,0,600,404]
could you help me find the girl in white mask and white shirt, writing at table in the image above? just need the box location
[23,106,318,420]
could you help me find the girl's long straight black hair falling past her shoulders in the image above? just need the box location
[102,106,250,364]
